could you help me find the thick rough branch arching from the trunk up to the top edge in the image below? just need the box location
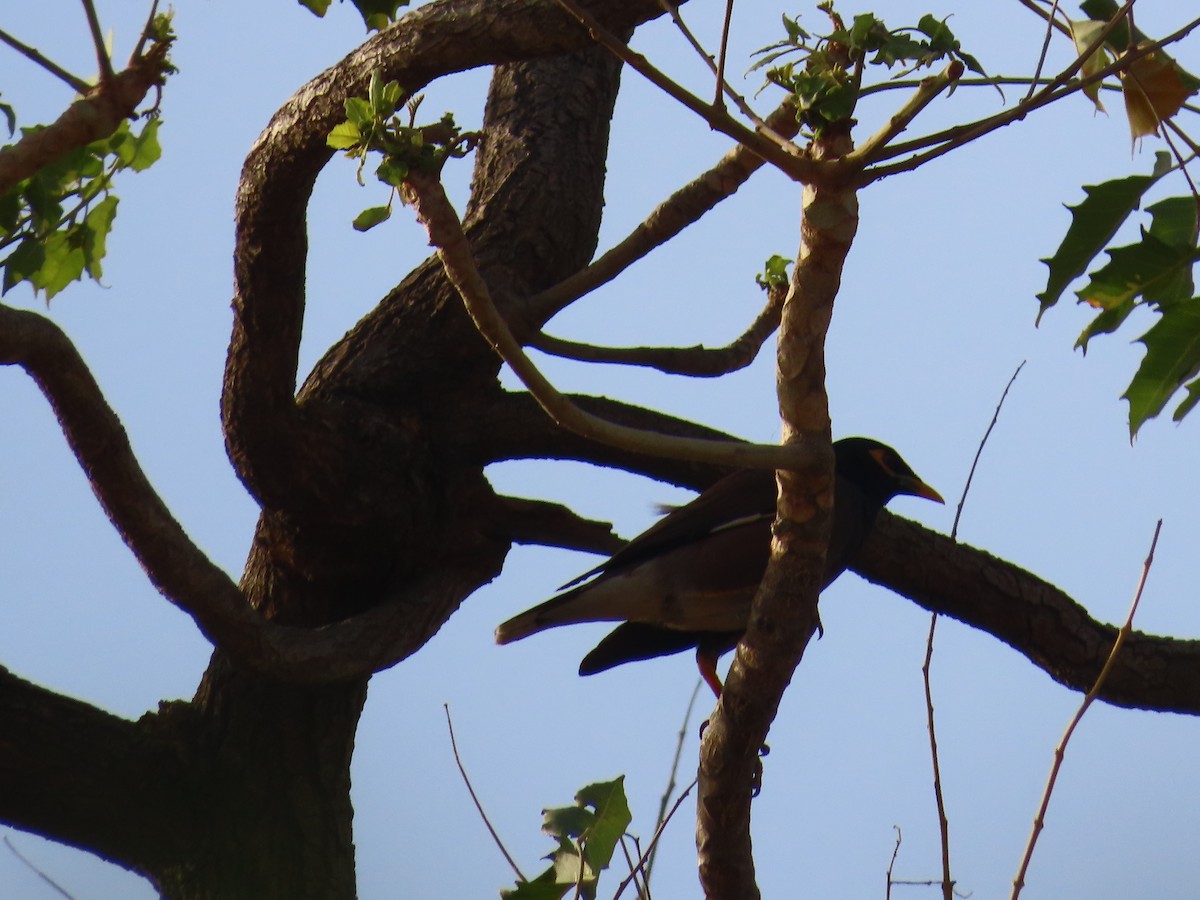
[222,0,662,508]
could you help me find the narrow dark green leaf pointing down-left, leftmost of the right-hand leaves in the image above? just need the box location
[1037,151,1171,322]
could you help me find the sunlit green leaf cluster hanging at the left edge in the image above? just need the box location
[0,118,162,301]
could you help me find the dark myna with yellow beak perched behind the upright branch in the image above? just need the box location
[496,438,943,696]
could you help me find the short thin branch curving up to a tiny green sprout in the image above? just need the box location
[528,288,785,378]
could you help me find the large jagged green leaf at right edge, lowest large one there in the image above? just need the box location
[1121,298,1200,438]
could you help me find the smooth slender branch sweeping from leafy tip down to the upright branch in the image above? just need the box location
[403,172,817,469]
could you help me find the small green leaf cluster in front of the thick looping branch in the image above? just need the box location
[325,71,479,232]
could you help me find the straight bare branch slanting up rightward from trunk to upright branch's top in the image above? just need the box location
[520,100,800,330]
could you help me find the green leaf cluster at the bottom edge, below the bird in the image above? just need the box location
[500,775,632,900]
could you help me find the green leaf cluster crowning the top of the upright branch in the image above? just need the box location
[750,2,986,134]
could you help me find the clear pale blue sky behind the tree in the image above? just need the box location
[0,0,1200,900]
